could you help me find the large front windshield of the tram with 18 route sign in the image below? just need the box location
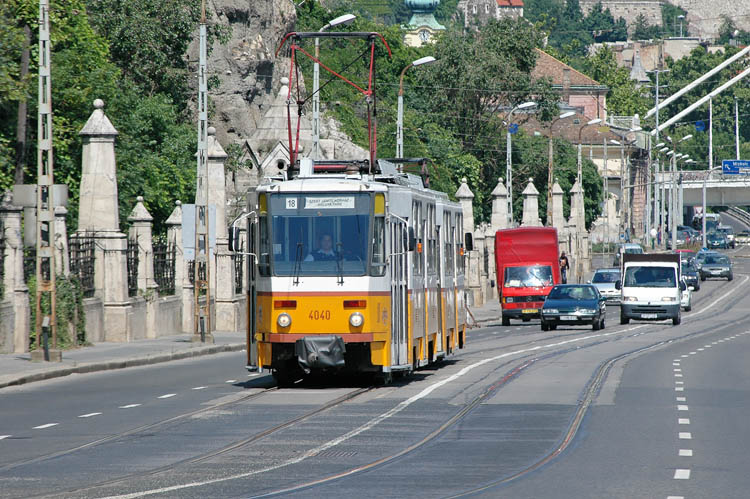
[261,193,372,276]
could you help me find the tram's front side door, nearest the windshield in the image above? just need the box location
[388,217,409,366]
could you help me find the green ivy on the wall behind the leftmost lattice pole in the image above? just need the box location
[27,274,86,350]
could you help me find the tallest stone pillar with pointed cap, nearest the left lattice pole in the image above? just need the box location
[78,99,133,341]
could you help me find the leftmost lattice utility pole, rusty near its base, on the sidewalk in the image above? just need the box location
[32,0,62,362]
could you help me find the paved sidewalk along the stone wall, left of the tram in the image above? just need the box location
[0,333,245,388]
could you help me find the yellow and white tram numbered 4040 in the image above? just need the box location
[241,159,466,384]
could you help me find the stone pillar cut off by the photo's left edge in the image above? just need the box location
[0,195,31,353]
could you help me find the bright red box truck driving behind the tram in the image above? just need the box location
[495,227,561,326]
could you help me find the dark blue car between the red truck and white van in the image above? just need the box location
[542,284,607,331]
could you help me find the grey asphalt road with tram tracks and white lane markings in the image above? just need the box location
[0,248,750,498]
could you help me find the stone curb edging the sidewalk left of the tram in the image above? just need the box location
[0,343,245,389]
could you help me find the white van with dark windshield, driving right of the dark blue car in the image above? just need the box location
[615,253,685,326]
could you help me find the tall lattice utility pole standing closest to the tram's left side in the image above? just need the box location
[193,0,213,343]
